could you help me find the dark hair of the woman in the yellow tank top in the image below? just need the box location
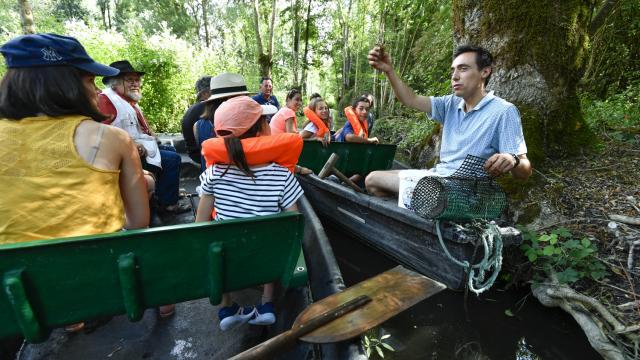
[0,66,109,121]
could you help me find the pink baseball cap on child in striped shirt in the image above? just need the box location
[213,96,278,137]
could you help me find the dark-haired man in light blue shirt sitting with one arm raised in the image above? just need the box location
[365,45,532,205]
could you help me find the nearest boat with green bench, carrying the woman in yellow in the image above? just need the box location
[0,188,364,360]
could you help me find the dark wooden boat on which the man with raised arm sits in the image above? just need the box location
[298,141,521,289]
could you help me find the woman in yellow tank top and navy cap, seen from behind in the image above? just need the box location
[0,34,149,244]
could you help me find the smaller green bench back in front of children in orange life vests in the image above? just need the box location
[298,140,396,176]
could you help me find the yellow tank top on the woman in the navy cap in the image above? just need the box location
[0,116,124,244]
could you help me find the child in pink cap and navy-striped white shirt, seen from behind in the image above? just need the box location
[196,96,303,330]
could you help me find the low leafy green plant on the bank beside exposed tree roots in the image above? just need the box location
[520,227,607,283]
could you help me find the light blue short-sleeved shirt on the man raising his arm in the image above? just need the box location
[427,92,527,176]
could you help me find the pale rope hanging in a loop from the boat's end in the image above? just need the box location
[436,220,502,295]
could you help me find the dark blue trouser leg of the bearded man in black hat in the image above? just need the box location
[156,146,182,207]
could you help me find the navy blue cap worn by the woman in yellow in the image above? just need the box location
[0,34,120,76]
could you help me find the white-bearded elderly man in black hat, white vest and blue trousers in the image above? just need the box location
[98,60,189,213]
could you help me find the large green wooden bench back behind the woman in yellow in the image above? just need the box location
[0,212,307,342]
